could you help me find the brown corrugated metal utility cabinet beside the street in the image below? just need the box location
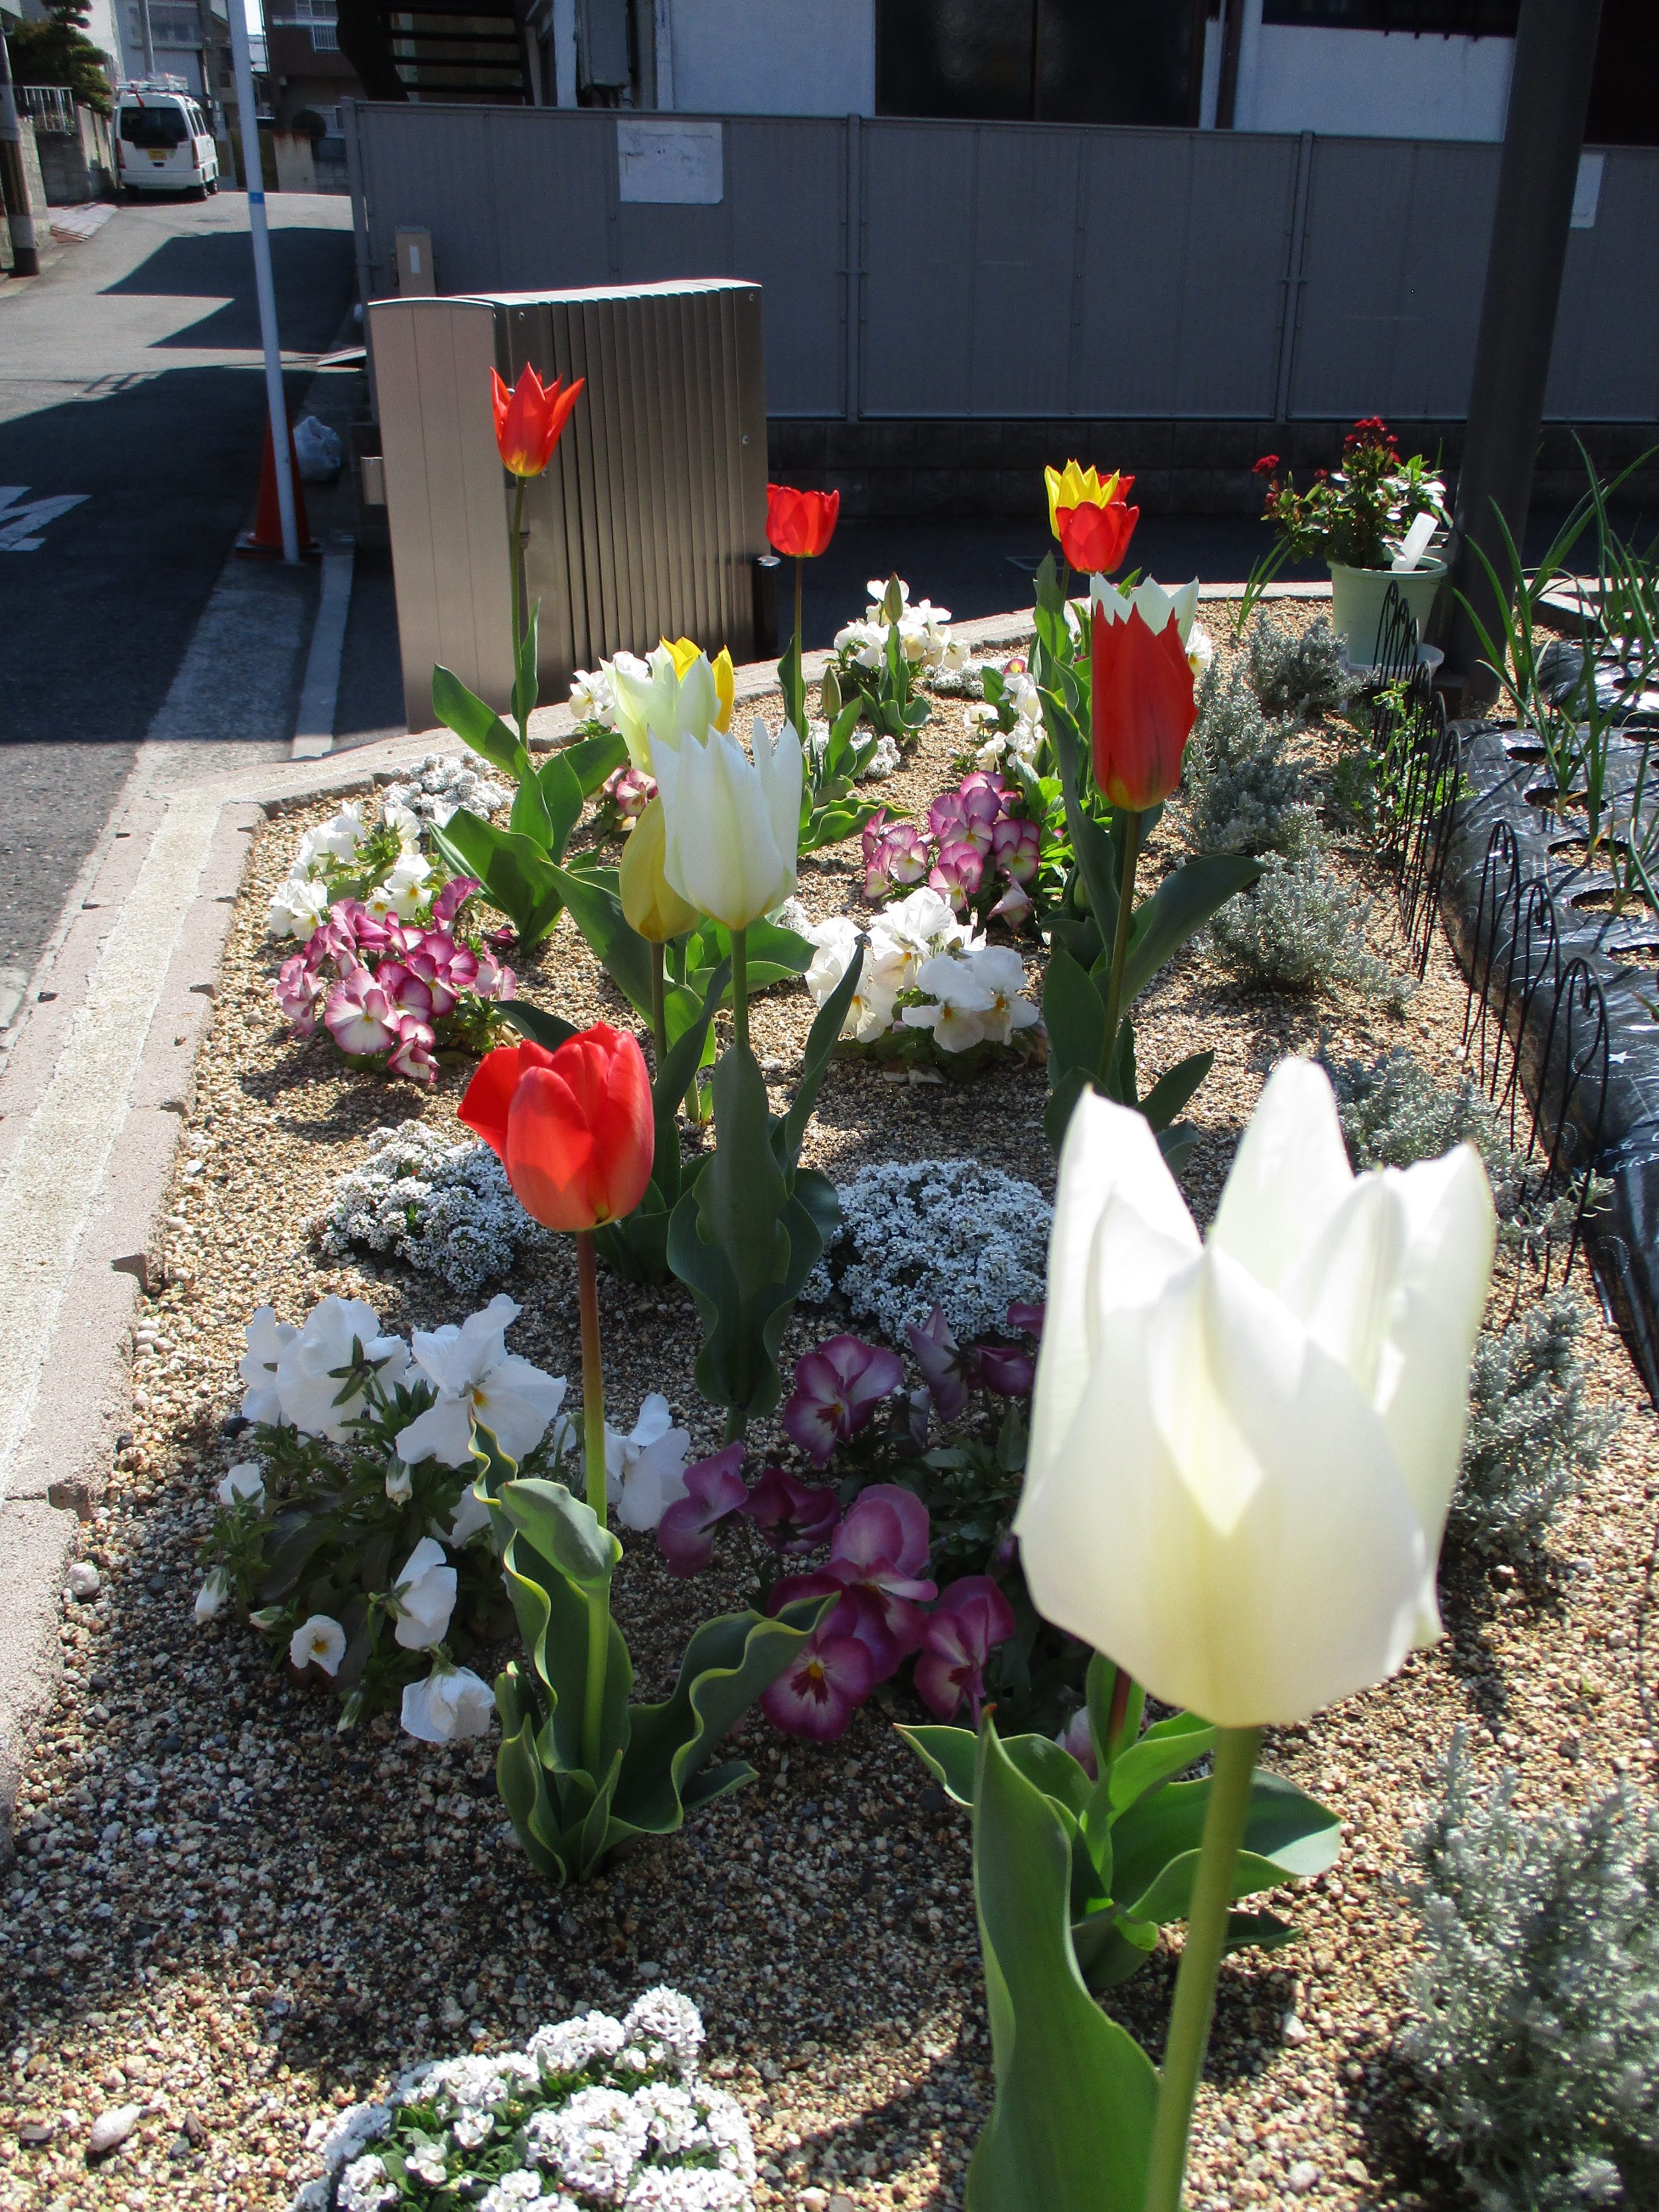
[370,279,768,730]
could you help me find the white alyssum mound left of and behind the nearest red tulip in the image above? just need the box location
[319,1122,546,1296]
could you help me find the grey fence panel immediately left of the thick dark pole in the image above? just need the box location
[1289,139,1500,420]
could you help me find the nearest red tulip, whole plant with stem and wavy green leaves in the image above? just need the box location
[460,1022,830,1882]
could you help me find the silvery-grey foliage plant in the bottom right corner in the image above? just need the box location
[1402,1736,1659,2212]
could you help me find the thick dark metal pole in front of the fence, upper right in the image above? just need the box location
[1438,0,1601,703]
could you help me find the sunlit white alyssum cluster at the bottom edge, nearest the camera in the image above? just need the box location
[294,1988,757,2212]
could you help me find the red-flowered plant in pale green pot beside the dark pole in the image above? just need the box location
[1256,416,1451,668]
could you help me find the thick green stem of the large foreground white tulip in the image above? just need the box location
[1146,1728,1261,2212]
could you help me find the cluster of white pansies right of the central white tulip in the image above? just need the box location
[805,885,1040,1053]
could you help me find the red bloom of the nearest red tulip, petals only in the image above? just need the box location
[460,1022,652,1230]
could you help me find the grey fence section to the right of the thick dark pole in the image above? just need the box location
[1544,146,1659,423]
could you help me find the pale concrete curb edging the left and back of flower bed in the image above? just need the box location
[0,586,1329,1856]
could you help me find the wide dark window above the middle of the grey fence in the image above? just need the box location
[876,0,1194,126]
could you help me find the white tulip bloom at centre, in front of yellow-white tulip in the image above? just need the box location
[650,715,801,929]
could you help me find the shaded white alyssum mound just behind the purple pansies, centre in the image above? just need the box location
[803,1159,1053,1343]
